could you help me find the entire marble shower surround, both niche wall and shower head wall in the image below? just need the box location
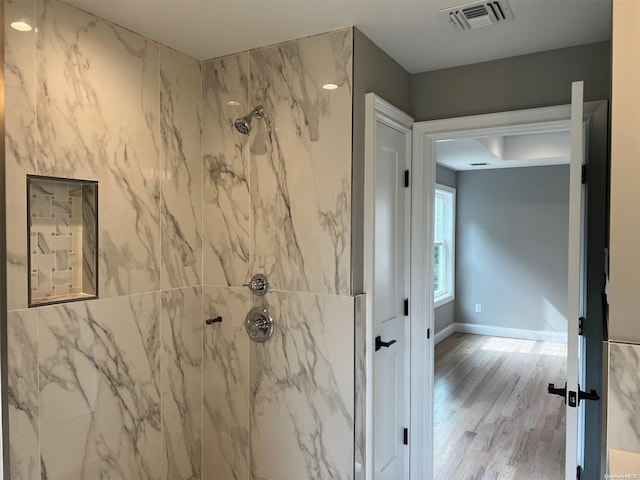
[5,0,354,480]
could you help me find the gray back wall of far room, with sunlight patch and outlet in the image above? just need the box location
[455,165,569,332]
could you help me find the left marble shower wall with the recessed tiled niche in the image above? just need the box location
[4,0,203,479]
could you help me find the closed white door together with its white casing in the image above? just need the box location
[364,94,413,480]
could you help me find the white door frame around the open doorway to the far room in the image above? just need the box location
[410,101,606,479]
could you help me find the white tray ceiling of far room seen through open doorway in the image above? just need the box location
[436,131,571,171]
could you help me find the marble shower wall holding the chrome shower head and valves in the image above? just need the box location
[202,29,354,479]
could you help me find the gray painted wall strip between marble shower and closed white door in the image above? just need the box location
[351,28,412,294]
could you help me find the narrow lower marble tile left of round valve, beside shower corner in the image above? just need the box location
[202,287,253,480]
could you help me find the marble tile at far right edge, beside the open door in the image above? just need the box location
[607,342,640,453]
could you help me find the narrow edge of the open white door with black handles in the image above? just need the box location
[565,82,584,480]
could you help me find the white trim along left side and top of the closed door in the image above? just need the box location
[364,93,413,480]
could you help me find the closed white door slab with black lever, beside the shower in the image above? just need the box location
[371,121,410,480]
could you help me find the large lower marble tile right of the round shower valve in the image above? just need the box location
[250,292,354,479]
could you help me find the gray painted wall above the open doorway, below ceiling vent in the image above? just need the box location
[411,42,611,121]
